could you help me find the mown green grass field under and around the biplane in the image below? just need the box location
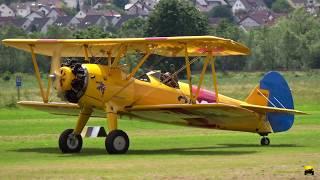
[0,71,320,179]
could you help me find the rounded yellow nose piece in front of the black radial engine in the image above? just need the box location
[59,67,75,91]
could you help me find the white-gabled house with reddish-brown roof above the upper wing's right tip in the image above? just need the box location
[238,9,279,30]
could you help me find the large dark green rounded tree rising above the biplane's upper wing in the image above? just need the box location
[146,0,208,36]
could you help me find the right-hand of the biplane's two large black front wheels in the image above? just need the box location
[105,130,129,154]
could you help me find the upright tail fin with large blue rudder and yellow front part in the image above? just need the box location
[246,71,294,132]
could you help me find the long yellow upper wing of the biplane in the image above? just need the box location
[2,36,250,57]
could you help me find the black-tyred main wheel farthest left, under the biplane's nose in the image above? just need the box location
[59,129,82,153]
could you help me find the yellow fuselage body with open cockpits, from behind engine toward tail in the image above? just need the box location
[80,64,243,110]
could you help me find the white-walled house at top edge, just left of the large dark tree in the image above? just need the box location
[124,0,152,15]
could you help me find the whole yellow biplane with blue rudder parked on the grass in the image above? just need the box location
[2,36,304,154]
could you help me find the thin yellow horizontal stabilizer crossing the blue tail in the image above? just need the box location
[240,104,307,114]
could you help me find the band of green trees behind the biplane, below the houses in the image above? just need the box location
[0,0,320,73]
